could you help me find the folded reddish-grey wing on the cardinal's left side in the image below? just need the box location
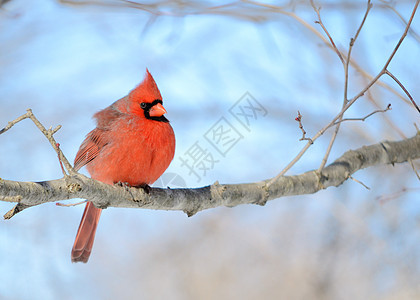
[74,128,108,171]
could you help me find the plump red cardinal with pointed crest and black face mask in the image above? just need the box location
[71,69,175,263]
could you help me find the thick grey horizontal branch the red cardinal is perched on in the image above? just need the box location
[0,134,420,218]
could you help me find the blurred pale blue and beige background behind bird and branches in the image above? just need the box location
[0,0,420,299]
